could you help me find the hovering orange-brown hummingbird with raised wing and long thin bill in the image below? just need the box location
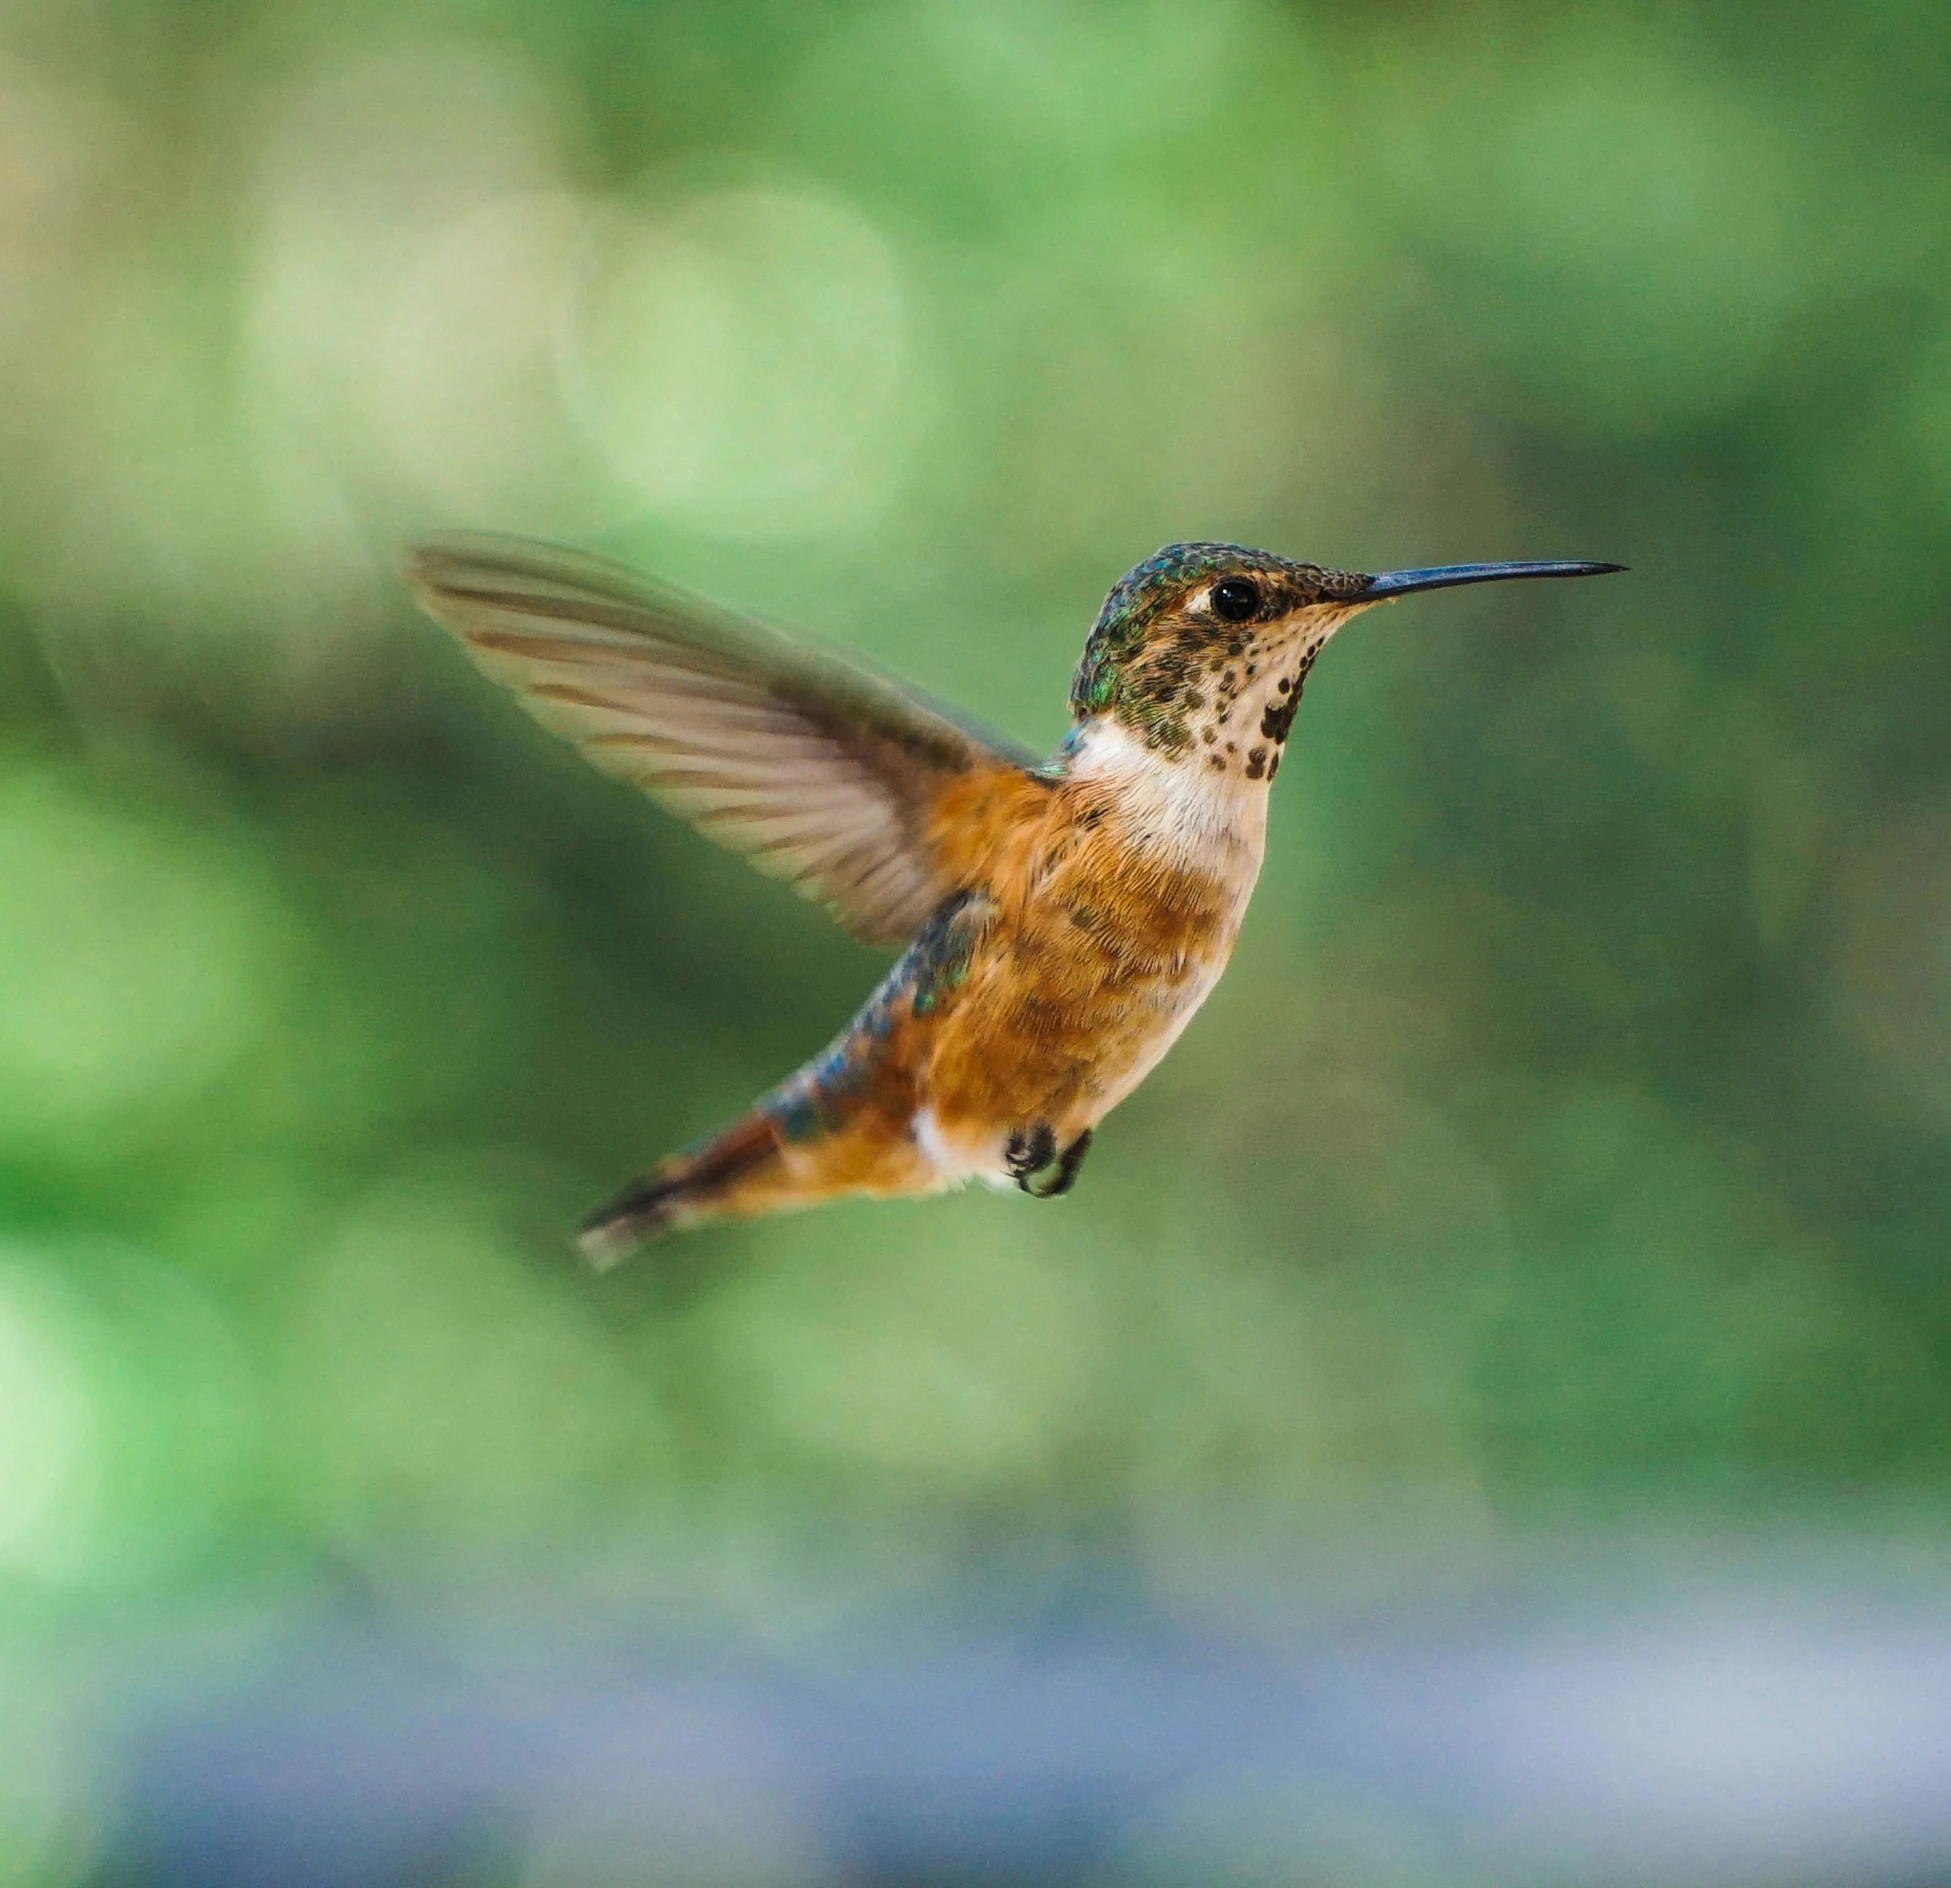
[408,534,1623,1266]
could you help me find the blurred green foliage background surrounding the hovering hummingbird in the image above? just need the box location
[0,0,1951,1884]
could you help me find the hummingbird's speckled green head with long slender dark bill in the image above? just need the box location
[1071,544,1621,780]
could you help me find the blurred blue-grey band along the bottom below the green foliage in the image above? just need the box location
[117,1539,1951,1888]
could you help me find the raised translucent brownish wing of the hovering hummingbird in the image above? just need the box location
[408,536,1036,944]
